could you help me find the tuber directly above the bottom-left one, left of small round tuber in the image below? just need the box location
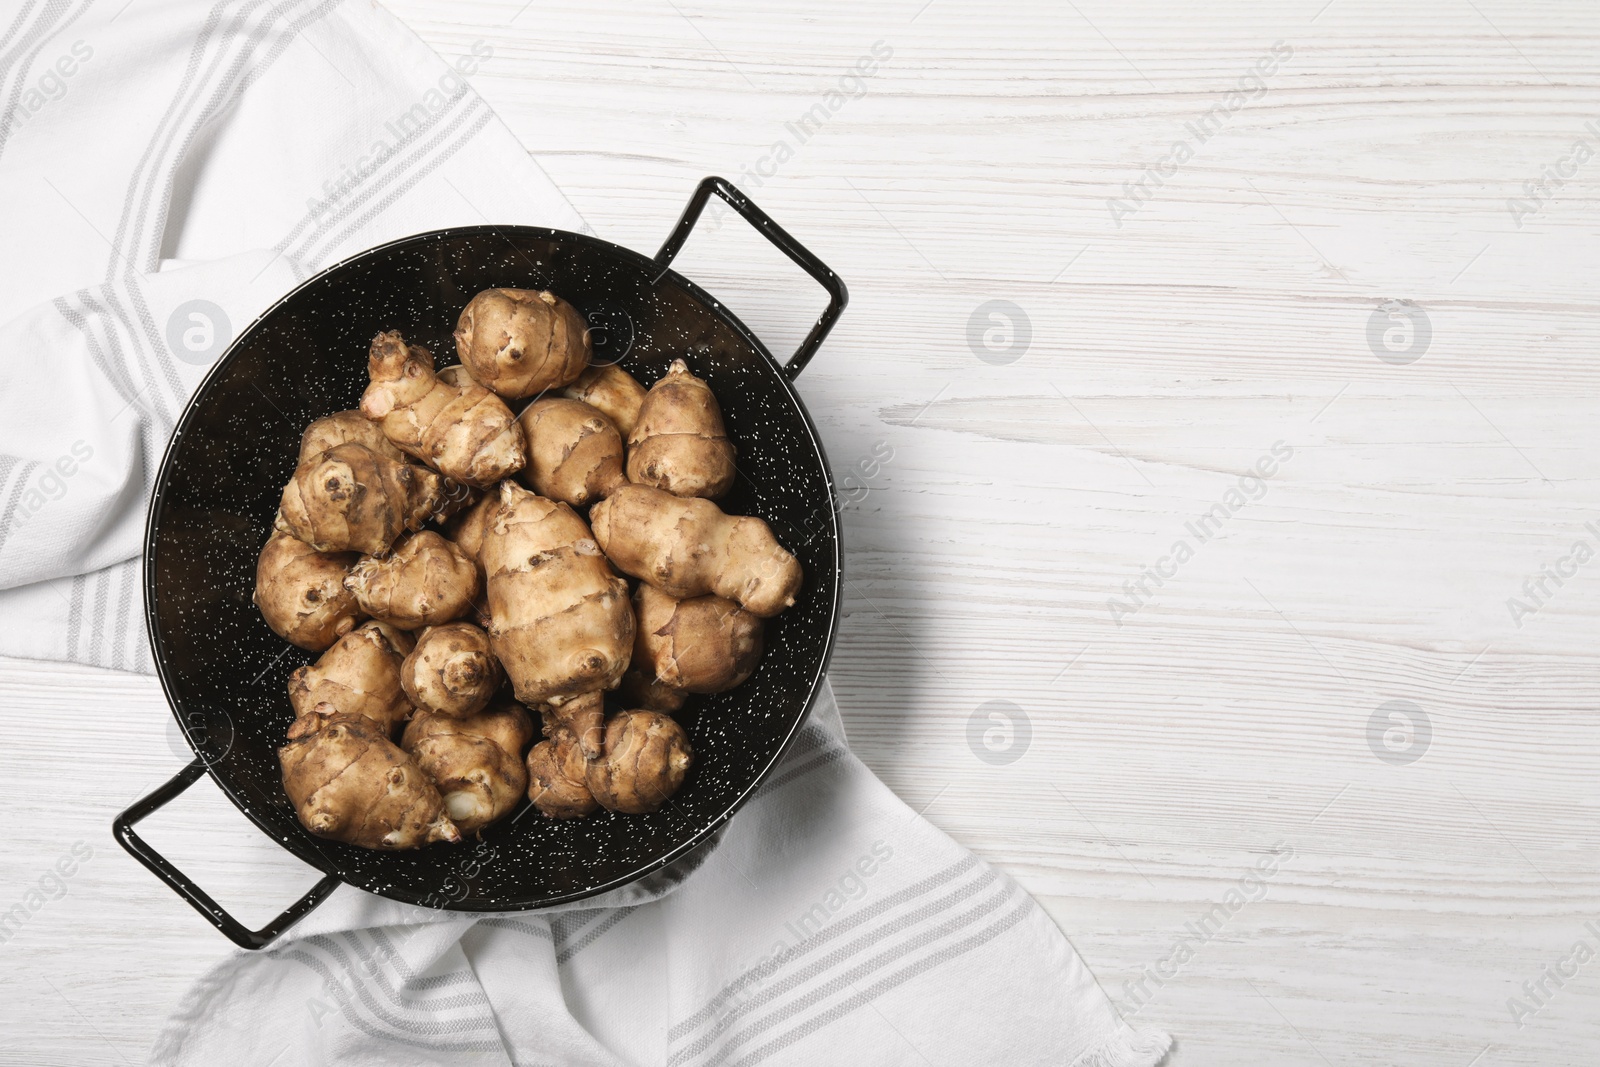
[290,622,413,737]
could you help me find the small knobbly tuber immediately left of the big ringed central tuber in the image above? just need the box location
[344,530,478,630]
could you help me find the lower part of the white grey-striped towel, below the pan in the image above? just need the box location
[152,691,1170,1067]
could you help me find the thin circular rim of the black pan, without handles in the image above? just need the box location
[139,224,845,913]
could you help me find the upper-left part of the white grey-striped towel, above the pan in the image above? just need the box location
[0,0,587,672]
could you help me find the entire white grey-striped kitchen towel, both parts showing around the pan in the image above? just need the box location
[0,0,1168,1067]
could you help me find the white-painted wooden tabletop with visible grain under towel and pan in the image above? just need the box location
[0,0,1600,1067]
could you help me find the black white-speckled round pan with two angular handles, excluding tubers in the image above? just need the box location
[114,178,846,949]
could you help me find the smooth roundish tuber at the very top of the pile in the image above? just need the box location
[456,290,590,398]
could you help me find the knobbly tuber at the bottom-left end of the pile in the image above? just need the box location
[278,713,461,849]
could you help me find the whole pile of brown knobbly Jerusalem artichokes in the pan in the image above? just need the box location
[254,290,802,849]
